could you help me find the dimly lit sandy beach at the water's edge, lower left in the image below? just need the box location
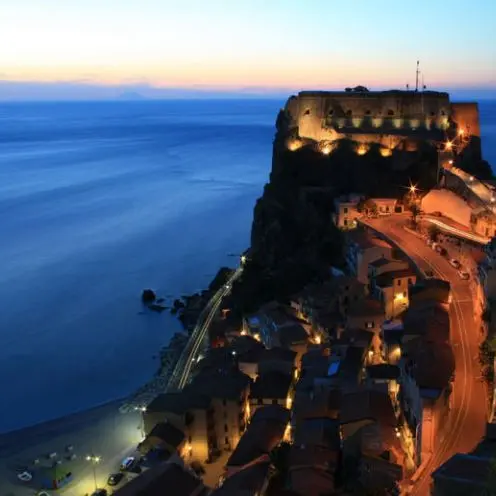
[0,401,142,496]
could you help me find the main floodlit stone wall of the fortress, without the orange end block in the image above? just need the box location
[292,91,451,141]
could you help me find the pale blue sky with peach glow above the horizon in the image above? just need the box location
[0,0,496,98]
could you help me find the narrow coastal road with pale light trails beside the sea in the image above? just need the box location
[167,265,243,392]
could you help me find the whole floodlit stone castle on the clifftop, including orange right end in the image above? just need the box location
[284,86,480,156]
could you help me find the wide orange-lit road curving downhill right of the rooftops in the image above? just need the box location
[367,216,486,496]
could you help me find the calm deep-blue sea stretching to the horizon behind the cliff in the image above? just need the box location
[0,99,496,432]
